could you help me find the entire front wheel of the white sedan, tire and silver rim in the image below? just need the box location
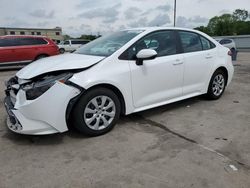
[71,88,121,136]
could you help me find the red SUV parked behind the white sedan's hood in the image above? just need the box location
[0,35,59,67]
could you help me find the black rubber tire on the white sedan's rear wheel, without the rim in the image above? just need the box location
[206,69,227,100]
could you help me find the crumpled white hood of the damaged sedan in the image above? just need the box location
[16,54,105,79]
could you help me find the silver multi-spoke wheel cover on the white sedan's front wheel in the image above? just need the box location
[84,95,116,130]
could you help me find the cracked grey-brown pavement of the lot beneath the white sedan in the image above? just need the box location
[0,53,250,188]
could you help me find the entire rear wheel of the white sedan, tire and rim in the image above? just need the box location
[207,69,227,100]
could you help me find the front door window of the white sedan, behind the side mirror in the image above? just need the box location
[128,31,177,60]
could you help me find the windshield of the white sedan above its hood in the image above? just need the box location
[74,30,143,57]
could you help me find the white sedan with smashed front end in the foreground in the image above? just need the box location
[5,27,234,136]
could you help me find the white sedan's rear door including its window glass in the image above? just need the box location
[178,31,216,95]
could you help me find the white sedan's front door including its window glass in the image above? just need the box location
[128,31,184,108]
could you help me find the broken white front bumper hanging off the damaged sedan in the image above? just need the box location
[4,82,80,135]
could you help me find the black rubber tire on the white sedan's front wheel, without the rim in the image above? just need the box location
[71,88,121,136]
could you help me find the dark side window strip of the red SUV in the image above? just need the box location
[0,38,48,47]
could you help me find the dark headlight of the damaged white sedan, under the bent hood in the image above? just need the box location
[22,73,73,100]
